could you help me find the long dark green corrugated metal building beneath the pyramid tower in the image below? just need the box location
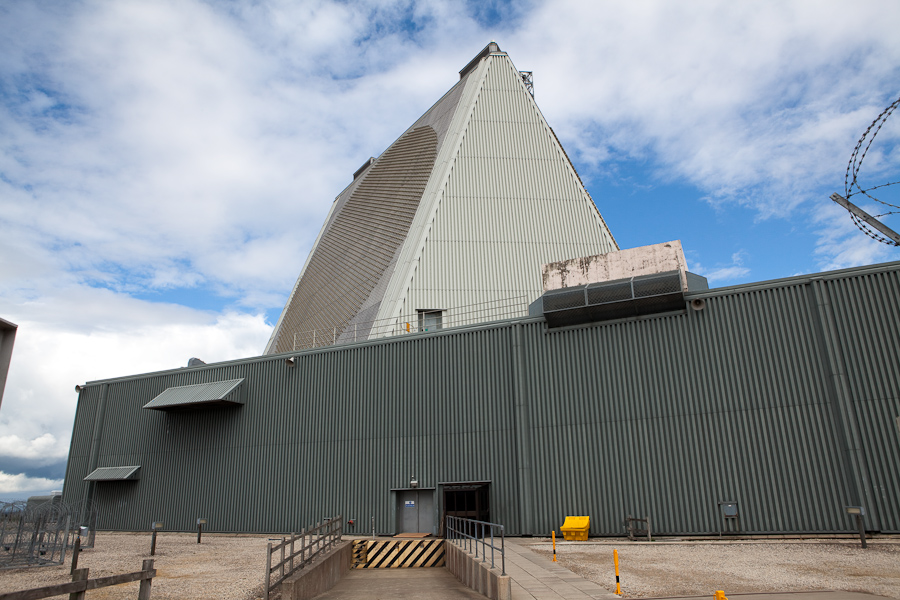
[63,263,900,535]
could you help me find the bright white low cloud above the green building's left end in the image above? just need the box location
[0,286,271,446]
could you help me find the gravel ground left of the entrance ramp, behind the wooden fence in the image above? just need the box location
[0,532,269,600]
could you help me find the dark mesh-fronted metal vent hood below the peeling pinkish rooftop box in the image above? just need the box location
[541,271,684,327]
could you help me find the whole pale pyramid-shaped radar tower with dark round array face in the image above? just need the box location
[266,42,618,354]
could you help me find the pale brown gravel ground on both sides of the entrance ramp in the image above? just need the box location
[0,533,900,600]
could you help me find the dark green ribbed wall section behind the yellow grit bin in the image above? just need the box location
[526,278,848,535]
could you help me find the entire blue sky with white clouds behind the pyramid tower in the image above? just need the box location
[0,0,900,499]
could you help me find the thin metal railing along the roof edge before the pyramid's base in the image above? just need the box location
[292,296,528,351]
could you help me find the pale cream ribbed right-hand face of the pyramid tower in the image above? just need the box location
[399,55,616,316]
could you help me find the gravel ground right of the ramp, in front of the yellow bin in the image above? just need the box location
[531,540,900,599]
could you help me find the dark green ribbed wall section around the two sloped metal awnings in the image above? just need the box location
[65,328,518,532]
